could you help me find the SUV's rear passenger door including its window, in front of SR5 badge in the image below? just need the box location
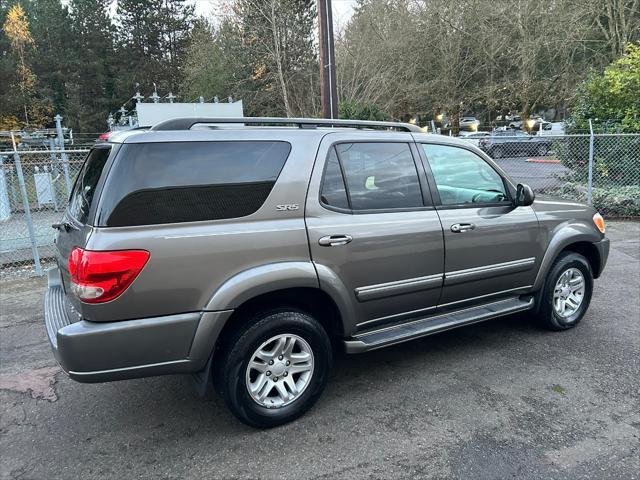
[305,132,444,335]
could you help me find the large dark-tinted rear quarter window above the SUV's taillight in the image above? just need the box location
[100,141,291,227]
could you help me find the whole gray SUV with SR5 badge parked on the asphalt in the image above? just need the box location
[44,118,609,427]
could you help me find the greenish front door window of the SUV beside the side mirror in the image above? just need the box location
[422,144,509,205]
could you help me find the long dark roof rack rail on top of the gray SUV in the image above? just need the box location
[151,117,423,132]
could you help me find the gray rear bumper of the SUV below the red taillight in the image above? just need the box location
[44,269,232,382]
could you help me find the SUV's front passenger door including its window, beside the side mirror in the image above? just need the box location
[420,144,543,307]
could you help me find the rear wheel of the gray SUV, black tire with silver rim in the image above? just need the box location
[214,309,332,428]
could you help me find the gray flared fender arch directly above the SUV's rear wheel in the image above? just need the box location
[204,262,319,311]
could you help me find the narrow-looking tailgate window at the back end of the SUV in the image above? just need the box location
[69,147,111,223]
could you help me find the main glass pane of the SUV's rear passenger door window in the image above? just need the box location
[336,143,424,210]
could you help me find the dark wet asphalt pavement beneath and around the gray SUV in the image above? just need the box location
[0,223,640,479]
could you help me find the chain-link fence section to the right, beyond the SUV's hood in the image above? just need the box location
[470,132,640,217]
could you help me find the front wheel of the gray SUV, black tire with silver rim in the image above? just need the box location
[537,252,593,331]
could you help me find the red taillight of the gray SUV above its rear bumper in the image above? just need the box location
[68,247,149,303]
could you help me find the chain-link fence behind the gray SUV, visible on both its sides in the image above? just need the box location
[0,132,640,278]
